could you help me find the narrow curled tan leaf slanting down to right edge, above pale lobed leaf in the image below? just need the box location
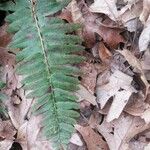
[118,49,149,96]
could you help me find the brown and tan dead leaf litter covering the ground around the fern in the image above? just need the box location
[0,0,150,150]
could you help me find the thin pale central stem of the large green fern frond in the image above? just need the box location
[30,0,61,143]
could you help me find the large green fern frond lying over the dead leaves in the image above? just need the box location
[6,0,83,149]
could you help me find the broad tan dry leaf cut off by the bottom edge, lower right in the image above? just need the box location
[97,113,150,150]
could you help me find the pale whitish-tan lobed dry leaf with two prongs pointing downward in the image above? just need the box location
[97,70,136,122]
